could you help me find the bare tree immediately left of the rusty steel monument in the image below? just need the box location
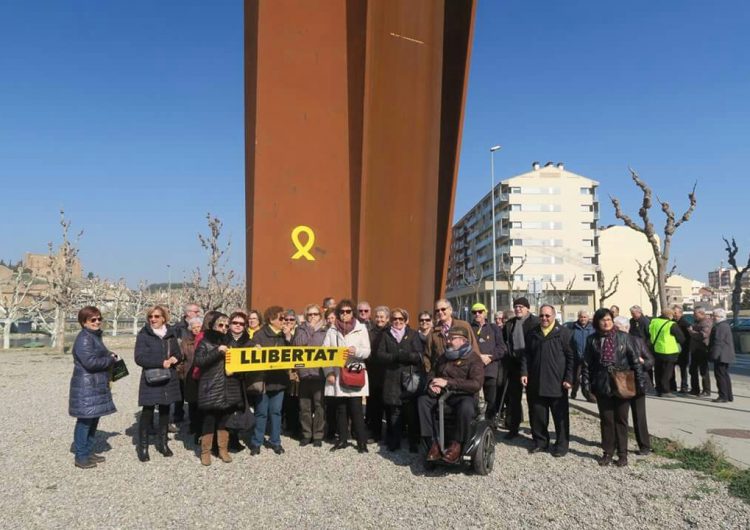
[190,213,234,312]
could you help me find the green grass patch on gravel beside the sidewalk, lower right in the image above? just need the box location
[651,436,750,504]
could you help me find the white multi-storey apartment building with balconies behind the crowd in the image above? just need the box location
[447,162,599,321]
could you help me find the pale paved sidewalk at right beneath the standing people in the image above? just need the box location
[570,354,750,468]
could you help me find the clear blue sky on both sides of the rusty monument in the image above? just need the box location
[0,0,750,284]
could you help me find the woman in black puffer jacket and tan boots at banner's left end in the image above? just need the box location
[195,312,244,466]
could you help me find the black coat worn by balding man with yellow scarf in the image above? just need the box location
[521,322,575,398]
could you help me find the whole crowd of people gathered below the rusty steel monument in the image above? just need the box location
[69,297,734,469]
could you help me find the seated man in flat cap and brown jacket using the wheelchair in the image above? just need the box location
[418,327,484,464]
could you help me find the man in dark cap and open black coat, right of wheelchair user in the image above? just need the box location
[503,297,539,440]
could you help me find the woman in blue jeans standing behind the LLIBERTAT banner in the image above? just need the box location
[247,306,289,456]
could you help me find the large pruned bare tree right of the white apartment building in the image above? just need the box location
[609,169,698,314]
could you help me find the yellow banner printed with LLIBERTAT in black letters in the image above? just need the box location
[224,346,347,373]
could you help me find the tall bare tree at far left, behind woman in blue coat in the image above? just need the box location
[47,210,83,353]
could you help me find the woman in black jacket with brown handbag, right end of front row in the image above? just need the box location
[581,308,646,467]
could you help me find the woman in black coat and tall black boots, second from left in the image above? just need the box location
[135,305,183,462]
